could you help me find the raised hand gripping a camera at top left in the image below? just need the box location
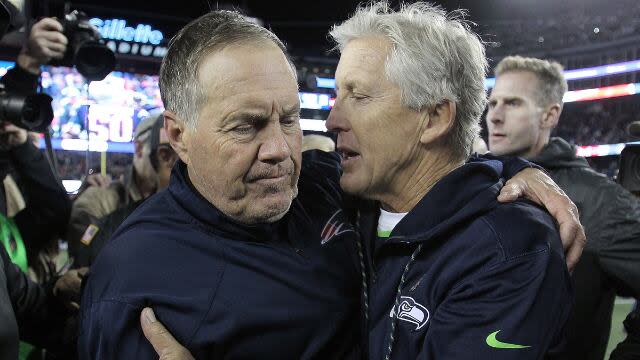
[18,18,68,75]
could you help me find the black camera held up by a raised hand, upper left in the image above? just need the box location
[50,10,116,81]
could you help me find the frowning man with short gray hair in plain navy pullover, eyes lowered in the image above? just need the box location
[79,4,579,359]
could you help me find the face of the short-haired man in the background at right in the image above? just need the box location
[486,71,543,157]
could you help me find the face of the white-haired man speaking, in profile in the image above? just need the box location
[327,37,422,199]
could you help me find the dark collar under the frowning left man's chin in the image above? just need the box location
[168,161,289,242]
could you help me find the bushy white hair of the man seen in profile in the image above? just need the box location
[330,1,488,159]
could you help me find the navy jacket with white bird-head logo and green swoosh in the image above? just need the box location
[359,160,572,360]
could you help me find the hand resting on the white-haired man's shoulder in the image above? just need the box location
[498,168,587,271]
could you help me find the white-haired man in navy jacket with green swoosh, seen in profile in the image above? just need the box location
[327,3,572,360]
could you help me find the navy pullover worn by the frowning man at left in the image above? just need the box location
[78,152,362,360]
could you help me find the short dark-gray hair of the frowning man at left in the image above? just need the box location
[160,10,296,128]
